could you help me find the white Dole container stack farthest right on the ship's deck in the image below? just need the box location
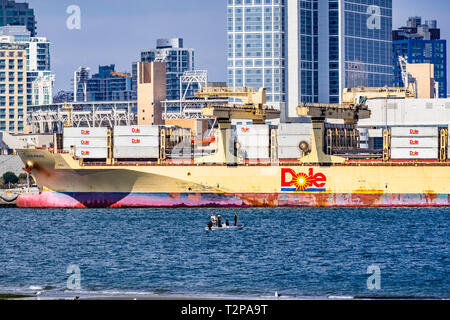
[391,127,439,160]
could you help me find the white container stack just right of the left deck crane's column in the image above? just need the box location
[236,124,270,160]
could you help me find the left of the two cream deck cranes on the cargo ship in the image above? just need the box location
[195,87,280,163]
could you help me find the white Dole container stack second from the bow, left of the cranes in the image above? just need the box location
[114,126,159,159]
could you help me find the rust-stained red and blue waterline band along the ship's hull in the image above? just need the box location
[17,192,450,209]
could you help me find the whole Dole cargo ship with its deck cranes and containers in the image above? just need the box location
[17,87,450,208]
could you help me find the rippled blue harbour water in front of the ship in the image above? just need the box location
[0,208,450,298]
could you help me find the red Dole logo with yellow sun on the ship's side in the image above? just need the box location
[281,168,327,191]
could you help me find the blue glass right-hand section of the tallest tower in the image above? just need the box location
[340,0,393,95]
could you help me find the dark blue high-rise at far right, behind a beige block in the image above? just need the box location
[392,17,447,98]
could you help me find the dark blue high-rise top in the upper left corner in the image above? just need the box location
[0,0,36,37]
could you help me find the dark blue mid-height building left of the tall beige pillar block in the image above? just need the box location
[74,64,134,102]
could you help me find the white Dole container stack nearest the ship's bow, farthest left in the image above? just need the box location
[63,128,108,159]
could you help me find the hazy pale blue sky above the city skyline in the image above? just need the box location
[22,0,450,91]
